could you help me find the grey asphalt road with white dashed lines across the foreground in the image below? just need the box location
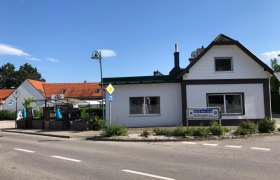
[0,132,280,180]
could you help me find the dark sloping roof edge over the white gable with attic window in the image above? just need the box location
[177,34,274,78]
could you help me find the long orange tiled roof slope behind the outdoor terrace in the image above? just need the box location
[43,82,102,99]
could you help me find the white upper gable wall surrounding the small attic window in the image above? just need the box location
[183,45,267,80]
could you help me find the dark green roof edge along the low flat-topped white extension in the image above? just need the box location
[103,75,177,85]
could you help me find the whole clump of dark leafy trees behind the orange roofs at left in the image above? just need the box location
[0,63,46,89]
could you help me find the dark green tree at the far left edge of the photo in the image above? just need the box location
[0,63,16,89]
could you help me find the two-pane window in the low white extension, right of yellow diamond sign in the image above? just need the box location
[129,96,160,114]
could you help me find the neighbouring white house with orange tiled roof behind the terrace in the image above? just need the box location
[3,79,102,111]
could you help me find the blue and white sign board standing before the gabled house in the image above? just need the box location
[187,107,220,120]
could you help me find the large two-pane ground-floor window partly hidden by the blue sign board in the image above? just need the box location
[207,93,244,115]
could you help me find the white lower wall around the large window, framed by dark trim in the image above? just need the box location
[186,84,265,119]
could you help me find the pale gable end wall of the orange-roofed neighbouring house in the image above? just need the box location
[3,80,44,111]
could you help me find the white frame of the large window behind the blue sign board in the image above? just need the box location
[206,93,245,115]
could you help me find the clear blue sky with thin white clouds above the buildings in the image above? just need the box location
[0,0,280,83]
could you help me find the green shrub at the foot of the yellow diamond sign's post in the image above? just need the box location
[101,124,128,137]
